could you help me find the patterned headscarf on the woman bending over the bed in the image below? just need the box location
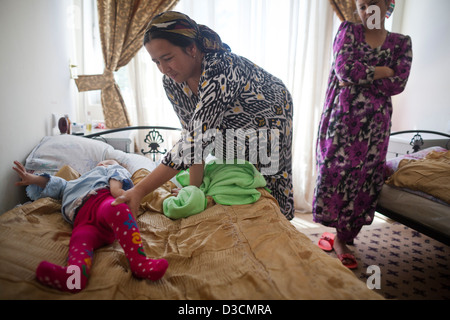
[145,11,231,53]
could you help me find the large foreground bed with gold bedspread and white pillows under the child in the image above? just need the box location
[0,127,382,300]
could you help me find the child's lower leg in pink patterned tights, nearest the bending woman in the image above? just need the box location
[104,204,169,281]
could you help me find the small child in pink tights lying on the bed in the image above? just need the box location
[13,160,168,292]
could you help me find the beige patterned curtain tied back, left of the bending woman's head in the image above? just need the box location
[76,0,178,129]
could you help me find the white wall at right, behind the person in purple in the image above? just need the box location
[392,0,450,133]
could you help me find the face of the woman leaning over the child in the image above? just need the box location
[145,39,197,83]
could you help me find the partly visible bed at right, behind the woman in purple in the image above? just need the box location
[377,130,450,245]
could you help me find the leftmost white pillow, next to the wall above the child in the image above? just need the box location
[25,134,114,174]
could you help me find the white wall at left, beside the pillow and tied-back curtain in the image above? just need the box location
[0,0,75,214]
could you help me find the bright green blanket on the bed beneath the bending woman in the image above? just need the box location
[163,160,266,219]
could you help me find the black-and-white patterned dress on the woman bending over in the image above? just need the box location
[162,51,295,219]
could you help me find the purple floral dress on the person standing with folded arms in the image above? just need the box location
[313,22,412,241]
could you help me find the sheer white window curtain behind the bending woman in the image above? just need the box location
[129,0,336,212]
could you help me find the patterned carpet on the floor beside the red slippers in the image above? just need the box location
[293,215,450,300]
